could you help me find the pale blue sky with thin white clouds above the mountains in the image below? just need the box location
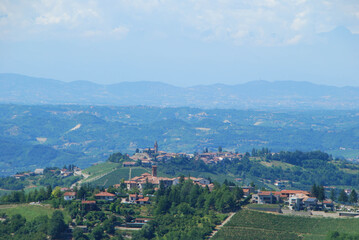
[0,0,359,86]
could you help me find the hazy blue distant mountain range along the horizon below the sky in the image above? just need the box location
[0,74,359,109]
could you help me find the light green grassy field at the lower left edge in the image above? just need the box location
[0,204,71,222]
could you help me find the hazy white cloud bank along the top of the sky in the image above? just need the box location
[0,0,359,45]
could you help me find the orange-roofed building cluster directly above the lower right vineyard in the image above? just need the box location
[251,190,334,211]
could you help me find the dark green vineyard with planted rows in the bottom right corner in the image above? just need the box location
[213,210,359,240]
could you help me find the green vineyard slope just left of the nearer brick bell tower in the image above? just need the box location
[91,167,149,187]
